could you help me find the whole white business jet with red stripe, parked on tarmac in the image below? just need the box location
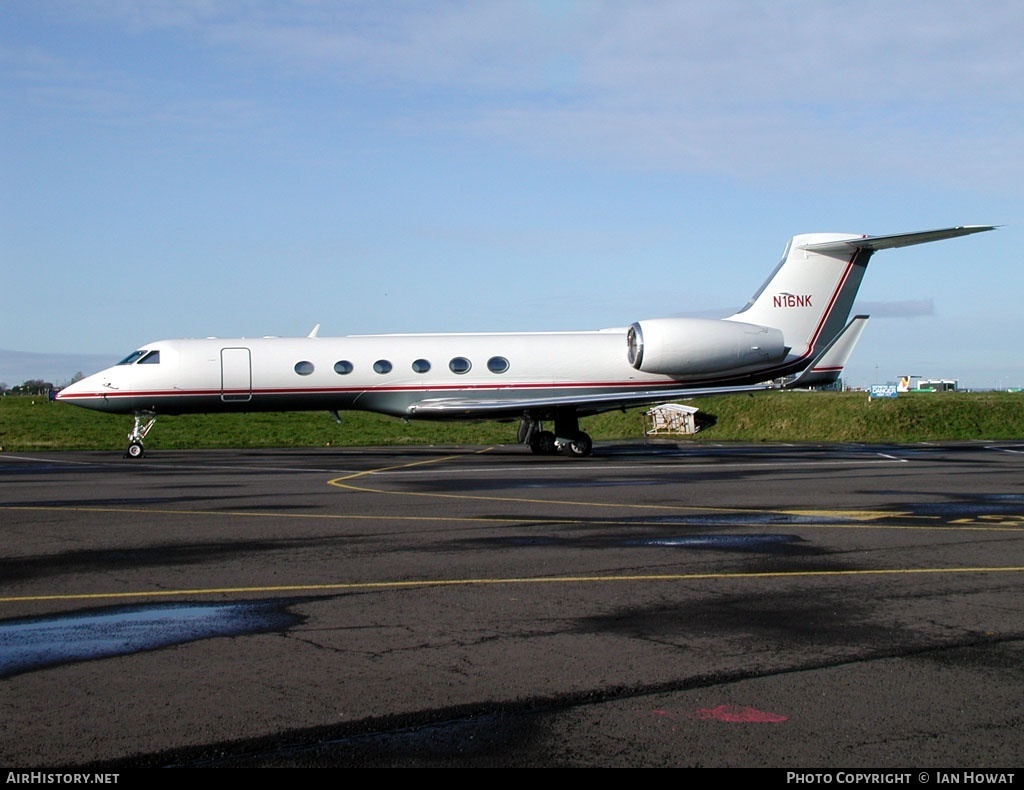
[57,225,994,458]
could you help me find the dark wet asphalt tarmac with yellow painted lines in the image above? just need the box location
[0,443,1024,770]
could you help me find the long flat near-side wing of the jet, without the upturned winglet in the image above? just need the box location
[409,383,771,419]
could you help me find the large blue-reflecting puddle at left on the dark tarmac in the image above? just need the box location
[0,601,302,677]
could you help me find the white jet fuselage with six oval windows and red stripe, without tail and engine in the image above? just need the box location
[59,329,790,419]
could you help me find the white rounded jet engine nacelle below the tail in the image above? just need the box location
[626,319,788,376]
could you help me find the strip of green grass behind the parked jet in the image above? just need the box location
[0,391,1024,453]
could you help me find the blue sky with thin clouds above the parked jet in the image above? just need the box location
[0,0,1024,387]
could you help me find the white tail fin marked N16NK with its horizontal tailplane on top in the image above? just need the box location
[727,225,994,363]
